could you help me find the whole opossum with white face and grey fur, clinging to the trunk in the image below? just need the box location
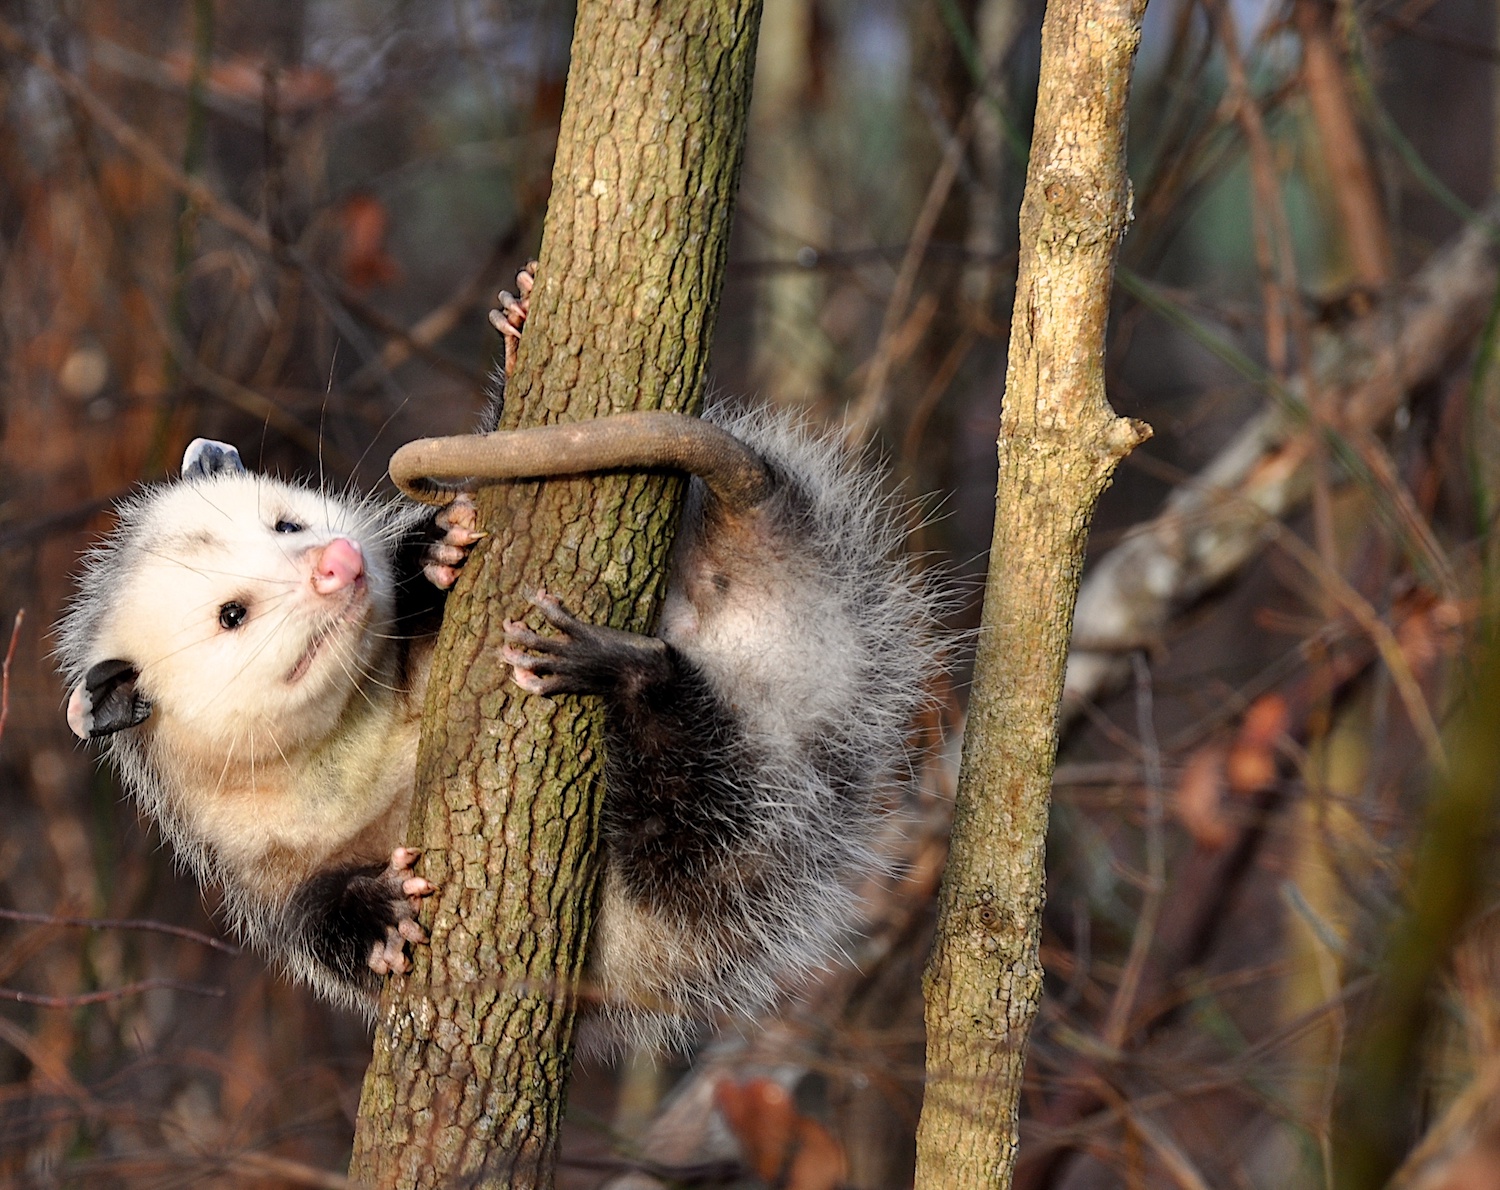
[59,274,941,1049]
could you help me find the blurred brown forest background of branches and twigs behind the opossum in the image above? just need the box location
[0,0,1500,1190]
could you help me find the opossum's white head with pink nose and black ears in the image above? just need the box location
[59,438,395,764]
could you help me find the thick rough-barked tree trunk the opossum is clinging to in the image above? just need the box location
[351,0,759,1187]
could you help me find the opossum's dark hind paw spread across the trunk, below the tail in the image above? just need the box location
[500,591,666,696]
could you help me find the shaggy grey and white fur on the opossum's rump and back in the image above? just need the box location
[585,405,942,1046]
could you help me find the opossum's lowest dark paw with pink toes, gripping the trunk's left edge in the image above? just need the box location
[293,846,437,983]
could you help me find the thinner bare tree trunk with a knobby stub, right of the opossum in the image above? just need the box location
[917,0,1149,1190]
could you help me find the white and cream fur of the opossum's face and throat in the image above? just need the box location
[59,473,416,933]
